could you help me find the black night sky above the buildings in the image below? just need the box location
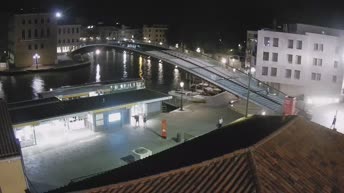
[0,0,344,48]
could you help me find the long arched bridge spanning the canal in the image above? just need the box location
[72,42,287,115]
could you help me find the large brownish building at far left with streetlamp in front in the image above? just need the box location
[8,13,57,68]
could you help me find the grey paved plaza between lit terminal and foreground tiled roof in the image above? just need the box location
[22,97,242,193]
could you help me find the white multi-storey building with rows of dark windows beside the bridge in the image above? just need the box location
[255,24,344,104]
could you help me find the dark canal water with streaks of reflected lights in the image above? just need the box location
[0,50,185,102]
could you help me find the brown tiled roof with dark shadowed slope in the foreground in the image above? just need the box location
[49,116,344,193]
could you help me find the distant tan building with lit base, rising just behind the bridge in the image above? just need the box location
[142,25,168,44]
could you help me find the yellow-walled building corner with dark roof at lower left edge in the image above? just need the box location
[0,99,28,193]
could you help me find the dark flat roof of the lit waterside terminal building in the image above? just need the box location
[9,89,169,124]
